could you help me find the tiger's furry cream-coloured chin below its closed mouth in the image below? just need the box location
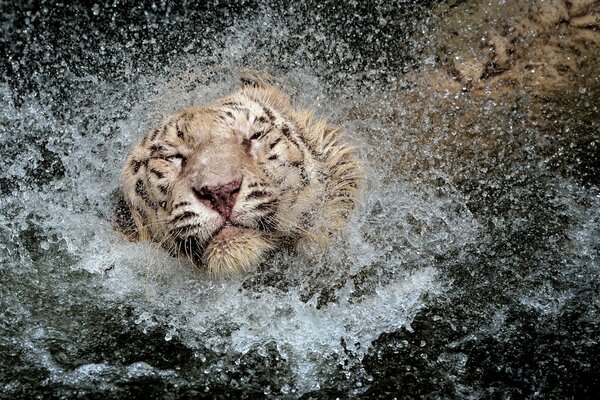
[202,226,275,278]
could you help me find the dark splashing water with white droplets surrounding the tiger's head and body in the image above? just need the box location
[0,1,600,399]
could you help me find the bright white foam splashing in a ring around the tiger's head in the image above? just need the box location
[3,59,486,393]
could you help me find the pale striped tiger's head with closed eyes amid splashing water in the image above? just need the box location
[114,75,364,278]
